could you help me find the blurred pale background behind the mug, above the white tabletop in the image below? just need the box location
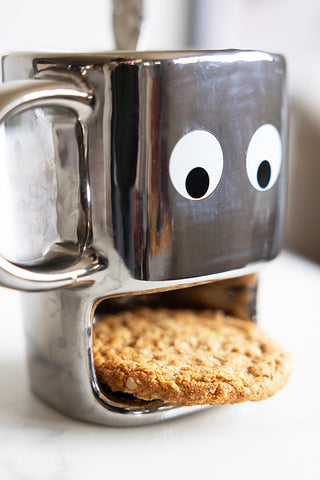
[0,0,320,262]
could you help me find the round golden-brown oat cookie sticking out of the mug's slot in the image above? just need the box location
[93,307,290,405]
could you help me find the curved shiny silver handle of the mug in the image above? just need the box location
[0,79,107,291]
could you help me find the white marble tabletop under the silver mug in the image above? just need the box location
[0,252,320,480]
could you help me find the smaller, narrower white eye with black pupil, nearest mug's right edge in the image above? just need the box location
[246,124,282,191]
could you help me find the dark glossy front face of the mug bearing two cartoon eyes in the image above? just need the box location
[106,52,285,280]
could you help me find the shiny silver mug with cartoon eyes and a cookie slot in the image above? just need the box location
[0,50,287,426]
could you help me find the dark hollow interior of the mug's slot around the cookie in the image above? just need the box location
[92,274,257,413]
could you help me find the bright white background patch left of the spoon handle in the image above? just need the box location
[0,0,112,52]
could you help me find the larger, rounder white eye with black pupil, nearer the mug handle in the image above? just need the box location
[169,130,223,200]
